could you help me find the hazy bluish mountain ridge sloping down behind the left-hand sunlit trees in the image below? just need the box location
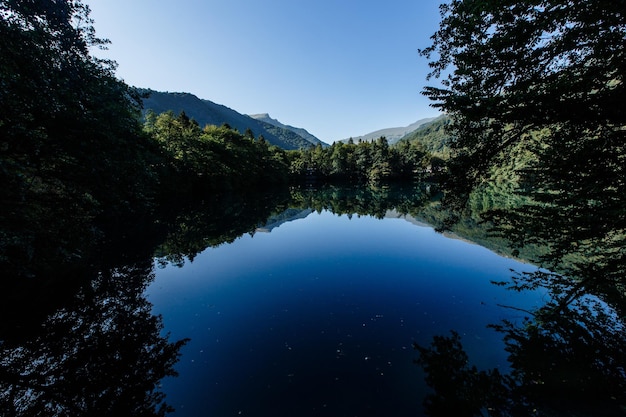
[140,90,311,149]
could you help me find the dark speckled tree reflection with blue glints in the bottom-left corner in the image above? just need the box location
[0,262,186,416]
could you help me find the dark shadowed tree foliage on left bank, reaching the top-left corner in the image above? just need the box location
[0,1,161,276]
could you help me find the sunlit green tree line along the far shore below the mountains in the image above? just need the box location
[144,111,443,186]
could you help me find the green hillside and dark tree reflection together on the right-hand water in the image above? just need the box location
[415,182,626,416]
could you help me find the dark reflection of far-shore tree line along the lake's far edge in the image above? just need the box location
[156,184,436,266]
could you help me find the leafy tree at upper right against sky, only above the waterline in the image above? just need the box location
[420,0,626,203]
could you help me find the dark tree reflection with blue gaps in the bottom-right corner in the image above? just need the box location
[416,273,626,416]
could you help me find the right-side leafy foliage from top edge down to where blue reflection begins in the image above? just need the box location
[422,0,626,280]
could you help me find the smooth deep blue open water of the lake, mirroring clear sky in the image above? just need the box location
[147,212,541,417]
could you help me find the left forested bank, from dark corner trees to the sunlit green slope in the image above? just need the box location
[0,1,292,279]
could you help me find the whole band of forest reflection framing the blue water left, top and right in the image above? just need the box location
[0,184,626,416]
